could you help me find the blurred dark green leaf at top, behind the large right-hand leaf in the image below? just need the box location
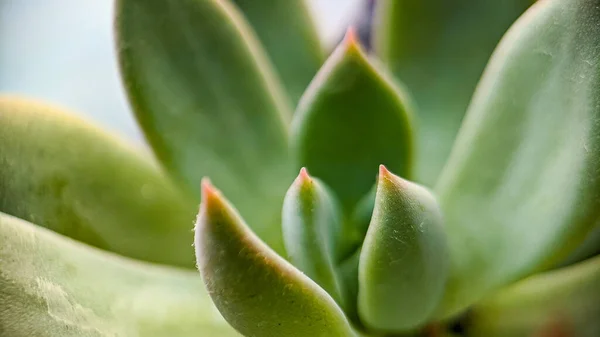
[374,0,533,186]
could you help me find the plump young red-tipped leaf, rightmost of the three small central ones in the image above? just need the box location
[358,165,449,332]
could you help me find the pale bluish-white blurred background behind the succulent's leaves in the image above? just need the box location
[0,0,367,141]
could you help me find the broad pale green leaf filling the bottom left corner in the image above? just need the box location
[0,213,239,337]
